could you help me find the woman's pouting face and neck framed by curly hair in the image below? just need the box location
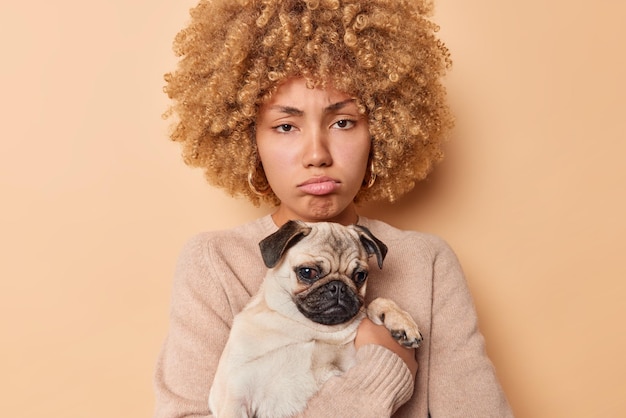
[256,78,370,225]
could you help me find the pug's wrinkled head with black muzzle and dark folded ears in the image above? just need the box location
[260,221,387,325]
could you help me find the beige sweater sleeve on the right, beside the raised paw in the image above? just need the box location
[428,239,513,418]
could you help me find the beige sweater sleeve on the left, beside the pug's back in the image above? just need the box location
[154,237,238,418]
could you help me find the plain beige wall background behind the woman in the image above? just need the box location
[0,0,626,418]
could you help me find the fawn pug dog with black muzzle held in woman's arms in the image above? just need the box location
[209,221,422,418]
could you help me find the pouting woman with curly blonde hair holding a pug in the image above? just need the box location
[156,0,512,418]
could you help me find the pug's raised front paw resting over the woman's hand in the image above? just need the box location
[367,298,424,348]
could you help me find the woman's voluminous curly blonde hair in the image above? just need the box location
[164,0,453,205]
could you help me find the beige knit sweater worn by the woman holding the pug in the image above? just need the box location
[155,216,512,418]
